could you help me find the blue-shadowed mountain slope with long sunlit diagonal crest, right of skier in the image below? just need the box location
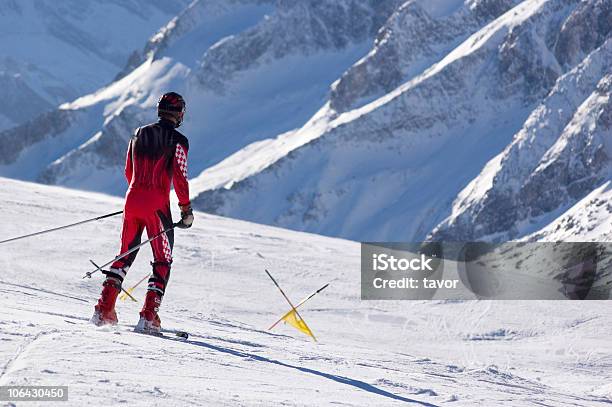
[195,0,598,241]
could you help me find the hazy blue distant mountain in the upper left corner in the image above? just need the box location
[0,0,187,130]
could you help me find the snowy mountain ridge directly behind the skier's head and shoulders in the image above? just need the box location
[0,0,399,193]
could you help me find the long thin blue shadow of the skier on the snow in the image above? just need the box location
[175,339,439,407]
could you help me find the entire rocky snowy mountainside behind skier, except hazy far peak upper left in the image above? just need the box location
[0,0,612,245]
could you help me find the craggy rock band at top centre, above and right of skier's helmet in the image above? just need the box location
[195,0,400,93]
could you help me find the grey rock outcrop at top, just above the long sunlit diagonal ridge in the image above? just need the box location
[330,0,520,112]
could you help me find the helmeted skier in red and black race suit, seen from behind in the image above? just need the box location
[91,92,193,333]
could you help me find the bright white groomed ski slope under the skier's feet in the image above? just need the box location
[0,179,612,406]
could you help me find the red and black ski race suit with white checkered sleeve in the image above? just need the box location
[109,119,190,295]
